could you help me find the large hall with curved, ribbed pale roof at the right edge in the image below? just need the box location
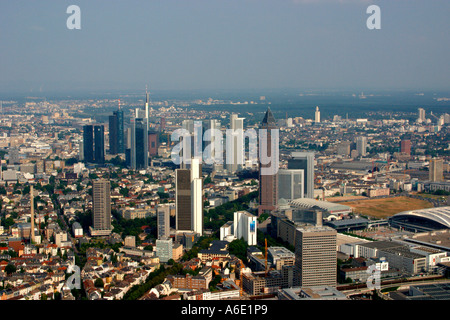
[390,206,450,229]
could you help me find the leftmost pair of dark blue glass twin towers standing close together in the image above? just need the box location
[83,125,105,164]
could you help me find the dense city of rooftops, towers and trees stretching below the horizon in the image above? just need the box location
[0,93,450,300]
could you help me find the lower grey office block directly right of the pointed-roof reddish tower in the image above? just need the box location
[278,169,304,201]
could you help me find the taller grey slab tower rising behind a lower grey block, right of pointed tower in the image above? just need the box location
[288,152,314,199]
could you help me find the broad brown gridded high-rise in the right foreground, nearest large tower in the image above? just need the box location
[294,214,337,287]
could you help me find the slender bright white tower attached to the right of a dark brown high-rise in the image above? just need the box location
[191,158,203,236]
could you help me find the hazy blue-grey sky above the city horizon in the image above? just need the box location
[0,0,450,93]
